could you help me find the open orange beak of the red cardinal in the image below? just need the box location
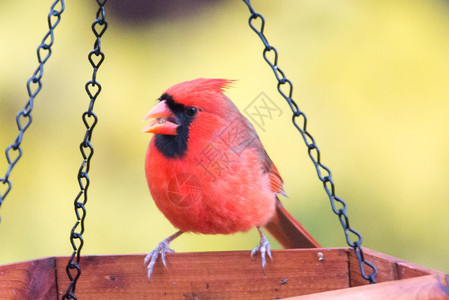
[142,100,179,135]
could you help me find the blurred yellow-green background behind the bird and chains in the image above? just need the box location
[0,0,449,272]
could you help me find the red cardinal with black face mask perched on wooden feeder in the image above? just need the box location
[143,78,318,279]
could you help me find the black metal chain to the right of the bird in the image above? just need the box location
[243,0,377,283]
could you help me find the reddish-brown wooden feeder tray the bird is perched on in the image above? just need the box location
[0,248,449,300]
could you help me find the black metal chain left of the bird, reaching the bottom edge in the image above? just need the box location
[62,0,108,299]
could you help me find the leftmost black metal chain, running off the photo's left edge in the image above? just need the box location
[0,0,65,220]
